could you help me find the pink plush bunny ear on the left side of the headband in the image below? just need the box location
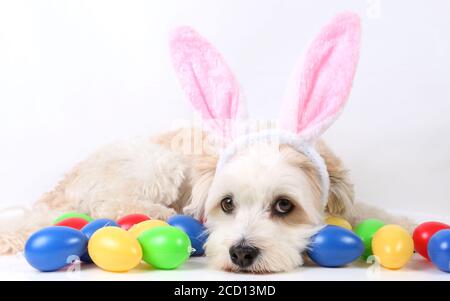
[170,27,246,138]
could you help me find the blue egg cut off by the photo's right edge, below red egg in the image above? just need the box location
[428,229,450,273]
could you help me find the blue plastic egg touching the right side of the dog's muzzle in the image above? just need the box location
[308,225,364,267]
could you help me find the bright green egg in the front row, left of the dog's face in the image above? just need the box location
[138,226,191,270]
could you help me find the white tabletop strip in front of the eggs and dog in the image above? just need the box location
[0,255,450,281]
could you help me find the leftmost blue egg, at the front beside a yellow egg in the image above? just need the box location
[24,226,88,272]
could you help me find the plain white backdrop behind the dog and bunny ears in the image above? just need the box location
[0,0,450,216]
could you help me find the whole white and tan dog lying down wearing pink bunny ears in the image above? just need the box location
[0,13,412,273]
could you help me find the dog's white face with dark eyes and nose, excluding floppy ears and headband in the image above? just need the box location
[205,146,322,272]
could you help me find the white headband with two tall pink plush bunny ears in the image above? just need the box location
[170,13,361,207]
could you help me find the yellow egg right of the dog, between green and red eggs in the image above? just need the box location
[372,225,414,270]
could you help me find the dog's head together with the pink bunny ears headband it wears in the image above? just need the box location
[171,13,360,272]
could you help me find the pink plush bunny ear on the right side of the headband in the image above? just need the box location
[281,13,361,140]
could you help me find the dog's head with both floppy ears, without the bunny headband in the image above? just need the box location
[185,142,353,273]
